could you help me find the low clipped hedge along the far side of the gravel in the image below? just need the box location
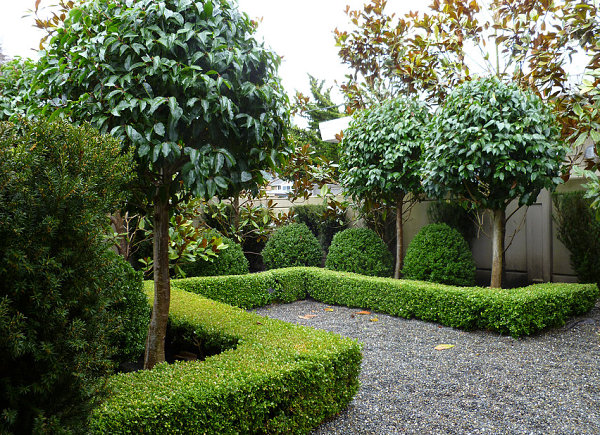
[175,267,600,337]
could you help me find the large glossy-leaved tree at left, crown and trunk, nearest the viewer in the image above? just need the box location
[34,0,288,368]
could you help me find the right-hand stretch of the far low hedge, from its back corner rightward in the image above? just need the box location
[307,270,600,337]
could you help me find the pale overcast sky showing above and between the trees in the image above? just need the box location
[0,0,429,103]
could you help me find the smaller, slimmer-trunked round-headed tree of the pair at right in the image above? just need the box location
[340,97,429,278]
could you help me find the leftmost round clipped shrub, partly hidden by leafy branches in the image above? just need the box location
[181,230,249,277]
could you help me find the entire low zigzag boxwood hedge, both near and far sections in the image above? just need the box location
[92,267,600,433]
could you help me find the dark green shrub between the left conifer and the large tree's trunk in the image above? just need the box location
[102,252,150,363]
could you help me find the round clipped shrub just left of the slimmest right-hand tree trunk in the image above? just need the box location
[325,228,394,276]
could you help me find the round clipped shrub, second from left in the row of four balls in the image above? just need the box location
[262,223,323,269]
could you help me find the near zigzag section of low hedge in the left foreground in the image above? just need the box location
[91,284,361,434]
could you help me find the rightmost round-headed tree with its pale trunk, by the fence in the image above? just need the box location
[423,78,566,288]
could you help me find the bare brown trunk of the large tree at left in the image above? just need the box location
[144,195,171,370]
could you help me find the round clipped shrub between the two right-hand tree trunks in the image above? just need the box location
[402,224,475,286]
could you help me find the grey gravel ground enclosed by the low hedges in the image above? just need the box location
[255,300,600,434]
